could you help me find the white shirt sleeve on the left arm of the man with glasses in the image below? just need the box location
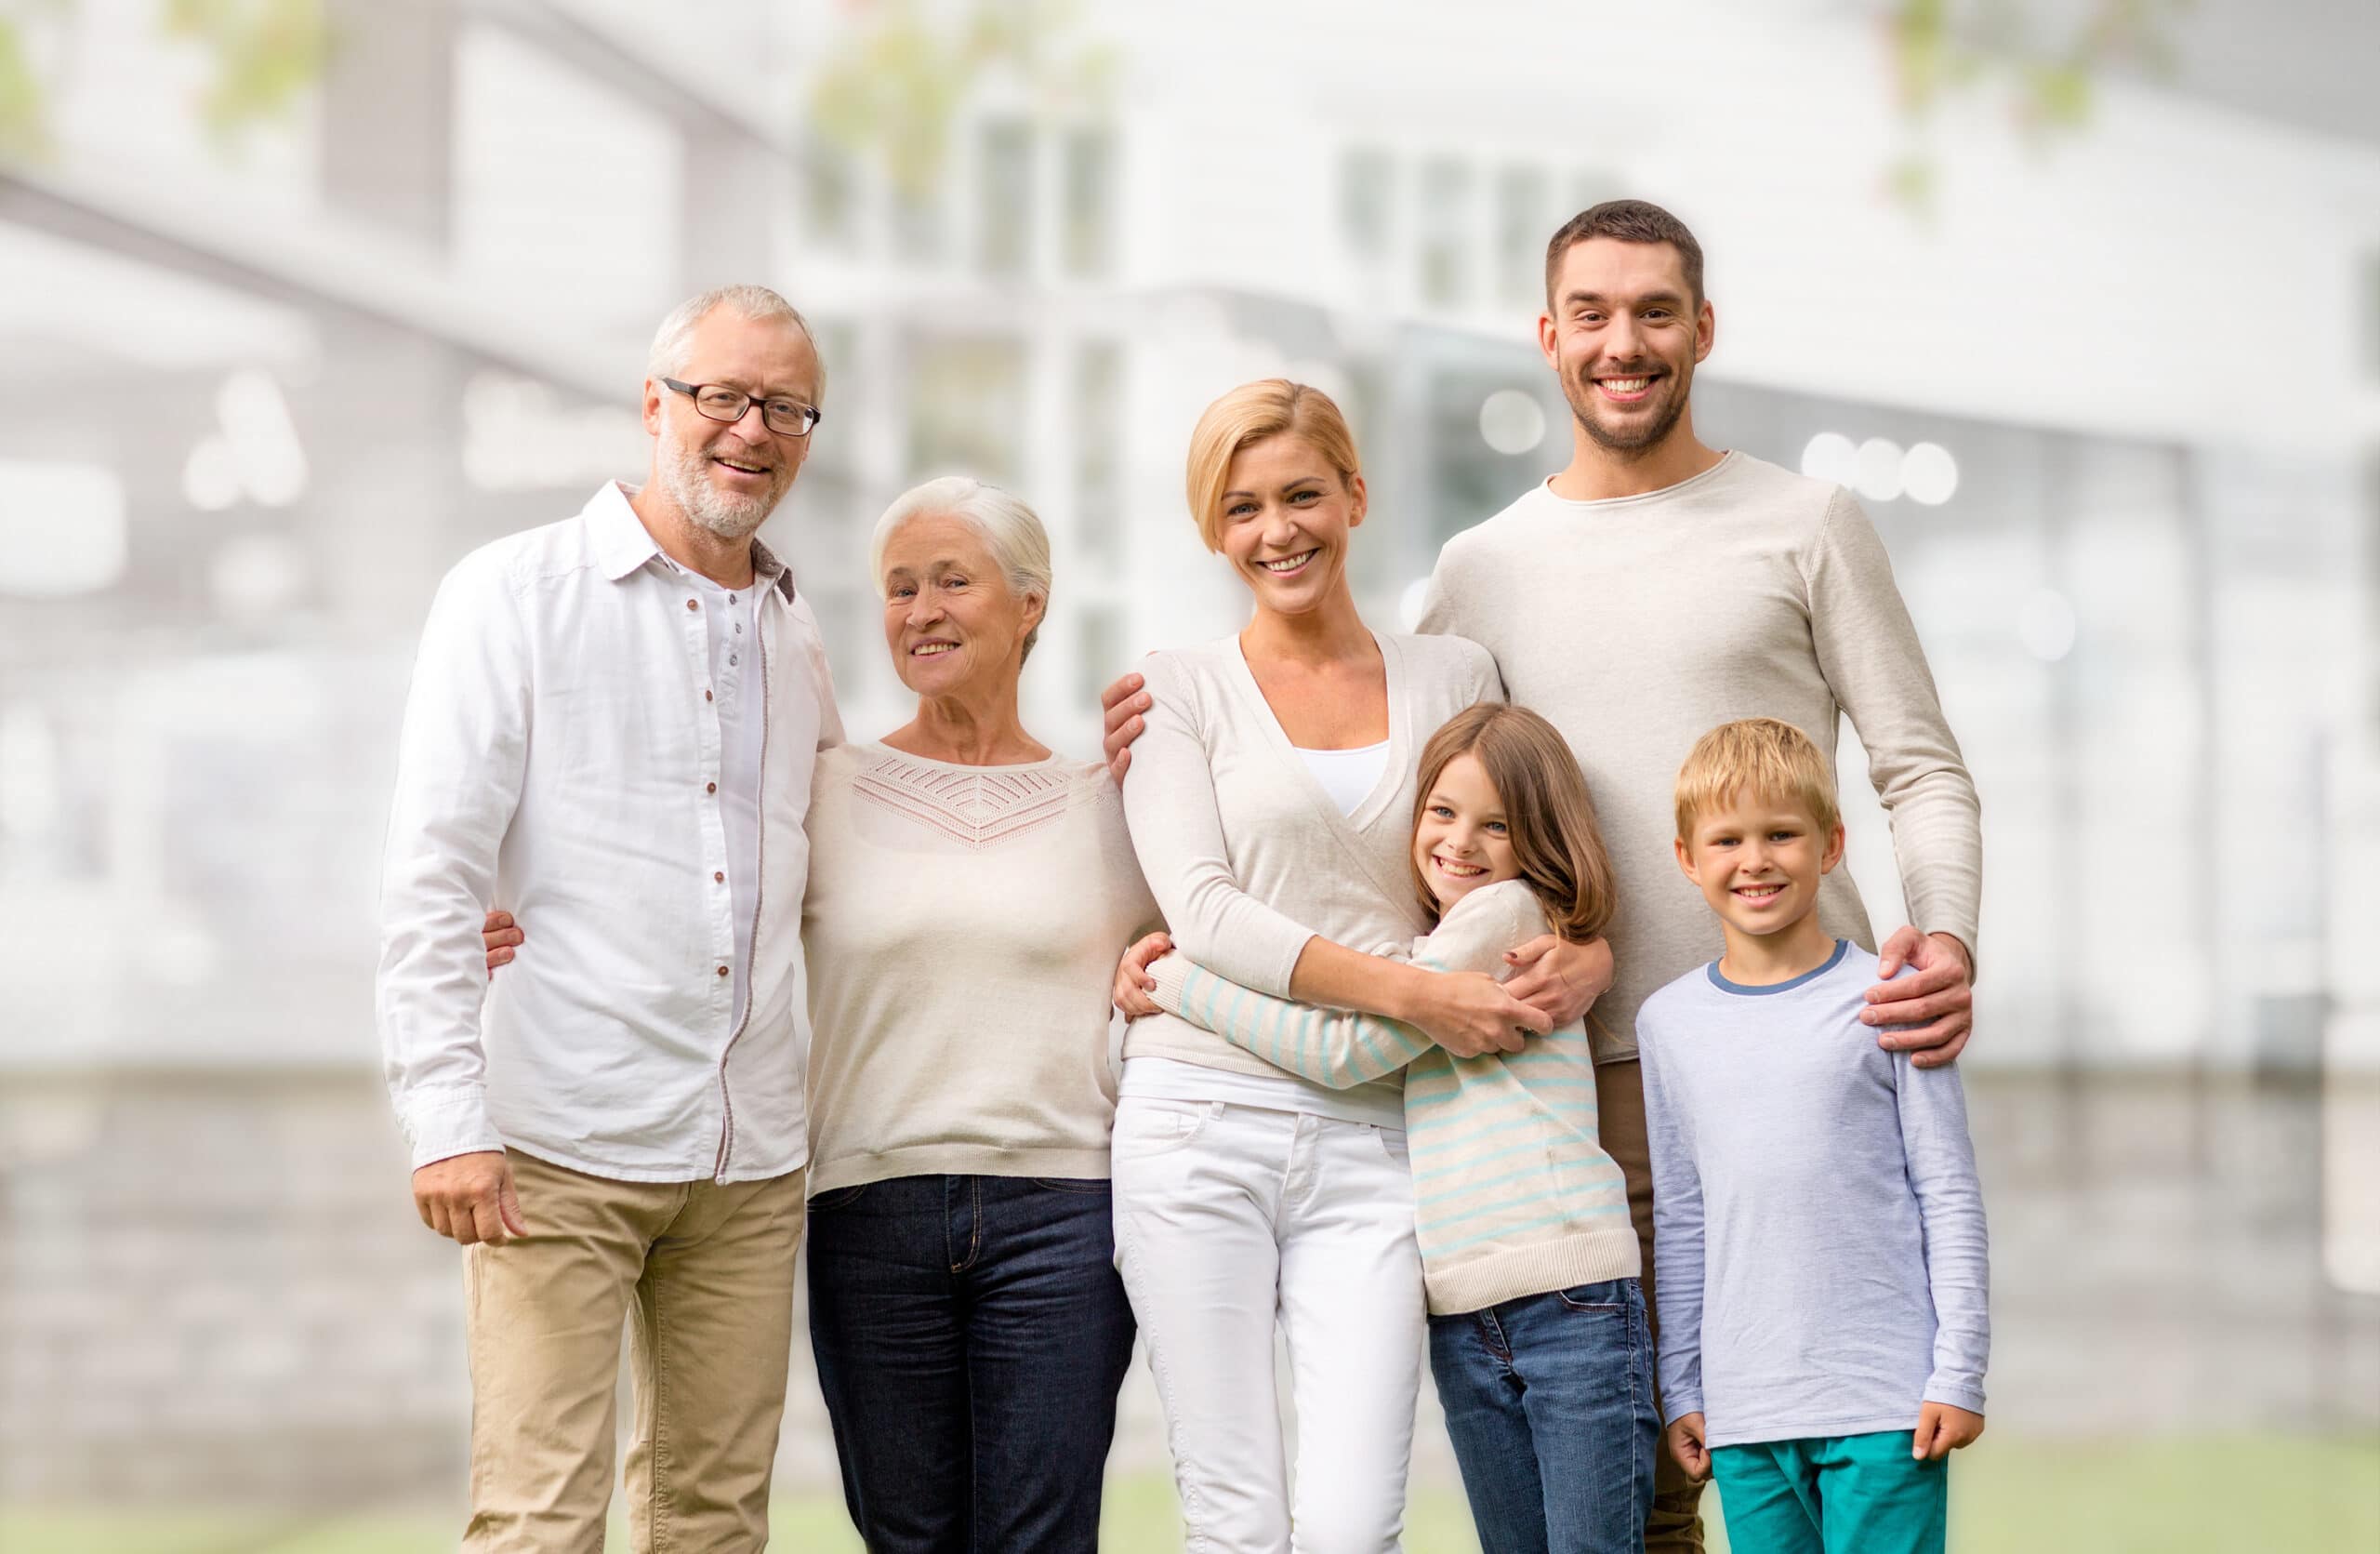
[374,552,531,1168]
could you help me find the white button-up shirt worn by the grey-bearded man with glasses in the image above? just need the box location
[378,485,842,1180]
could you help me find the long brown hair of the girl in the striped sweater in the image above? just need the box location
[1407,702,1614,942]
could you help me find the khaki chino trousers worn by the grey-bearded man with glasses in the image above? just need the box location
[462,1149,804,1554]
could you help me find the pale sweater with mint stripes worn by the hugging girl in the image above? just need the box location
[1149,881,1640,1314]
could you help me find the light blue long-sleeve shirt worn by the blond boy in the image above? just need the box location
[1637,940,1992,1447]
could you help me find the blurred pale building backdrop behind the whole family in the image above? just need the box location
[0,0,2380,1542]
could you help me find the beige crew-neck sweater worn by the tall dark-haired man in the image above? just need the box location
[1421,452,1982,1061]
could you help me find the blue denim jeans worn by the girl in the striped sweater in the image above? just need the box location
[1431,1278,1661,1554]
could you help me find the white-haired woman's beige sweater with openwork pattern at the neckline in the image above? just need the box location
[802,745,1157,1192]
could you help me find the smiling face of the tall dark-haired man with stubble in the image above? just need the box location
[1538,238,1713,455]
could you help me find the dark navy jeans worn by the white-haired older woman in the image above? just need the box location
[809,1175,1133,1554]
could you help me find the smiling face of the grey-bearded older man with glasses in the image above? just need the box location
[645,307,819,540]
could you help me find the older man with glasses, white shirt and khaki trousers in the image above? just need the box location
[378,286,842,1551]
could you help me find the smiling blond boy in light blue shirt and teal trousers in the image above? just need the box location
[1637,719,1990,1554]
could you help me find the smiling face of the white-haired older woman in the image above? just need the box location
[883,514,1042,699]
